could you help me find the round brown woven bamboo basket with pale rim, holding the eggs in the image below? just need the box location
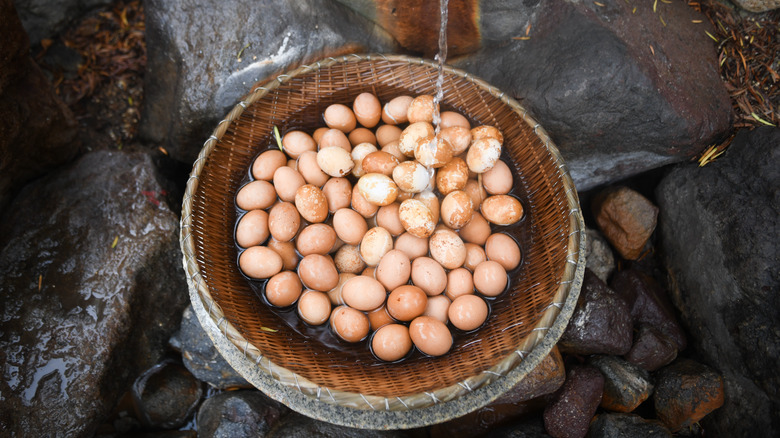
[181,55,585,428]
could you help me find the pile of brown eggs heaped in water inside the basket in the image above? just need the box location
[235,93,523,362]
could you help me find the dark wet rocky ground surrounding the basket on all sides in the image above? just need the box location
[0,0,780,437]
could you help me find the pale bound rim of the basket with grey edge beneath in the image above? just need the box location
[180,54,585,428]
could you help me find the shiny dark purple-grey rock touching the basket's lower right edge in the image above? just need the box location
[558,269,632,355]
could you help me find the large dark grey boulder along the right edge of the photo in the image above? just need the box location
[656,127,780,436]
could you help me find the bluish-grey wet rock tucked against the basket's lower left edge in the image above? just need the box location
[170,305,252,389]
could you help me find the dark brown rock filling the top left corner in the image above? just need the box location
[0,0,78,212]
